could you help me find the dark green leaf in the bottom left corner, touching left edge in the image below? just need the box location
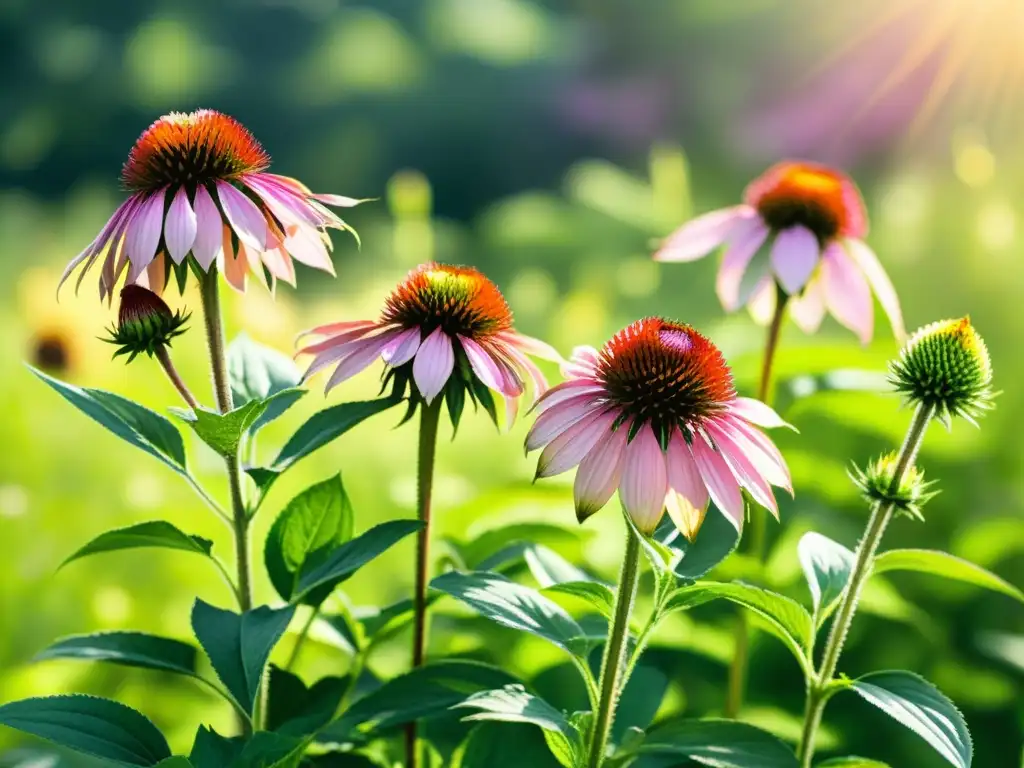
[0,694,171,766]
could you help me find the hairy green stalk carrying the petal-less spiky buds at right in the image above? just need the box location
[797,406,935,768]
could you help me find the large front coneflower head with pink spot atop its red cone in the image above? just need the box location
[526,317,793,540]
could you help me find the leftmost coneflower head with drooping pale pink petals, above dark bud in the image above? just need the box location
[60,110,361,298]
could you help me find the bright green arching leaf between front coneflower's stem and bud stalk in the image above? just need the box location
[666,582,813,669]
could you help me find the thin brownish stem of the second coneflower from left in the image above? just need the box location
[406,397,442,768]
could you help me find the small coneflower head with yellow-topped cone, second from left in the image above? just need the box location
[299,262,561,422]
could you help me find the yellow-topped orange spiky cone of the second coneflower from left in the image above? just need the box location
[383,262,512,340]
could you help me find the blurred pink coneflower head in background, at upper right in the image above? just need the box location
[654,161,905,344]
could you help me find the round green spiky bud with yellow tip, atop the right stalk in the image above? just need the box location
[889,317,992,426]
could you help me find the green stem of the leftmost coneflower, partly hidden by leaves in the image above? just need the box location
[201,268,253,733]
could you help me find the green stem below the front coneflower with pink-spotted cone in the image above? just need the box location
[587,525,640,768]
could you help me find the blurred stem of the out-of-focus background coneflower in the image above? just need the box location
[725,284,790,718]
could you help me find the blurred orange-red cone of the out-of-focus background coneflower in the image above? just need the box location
[744,162,867,244]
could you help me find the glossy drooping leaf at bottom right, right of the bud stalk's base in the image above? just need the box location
[850,671,974,768]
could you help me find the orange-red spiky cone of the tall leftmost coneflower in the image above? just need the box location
[121,110,270,191]
